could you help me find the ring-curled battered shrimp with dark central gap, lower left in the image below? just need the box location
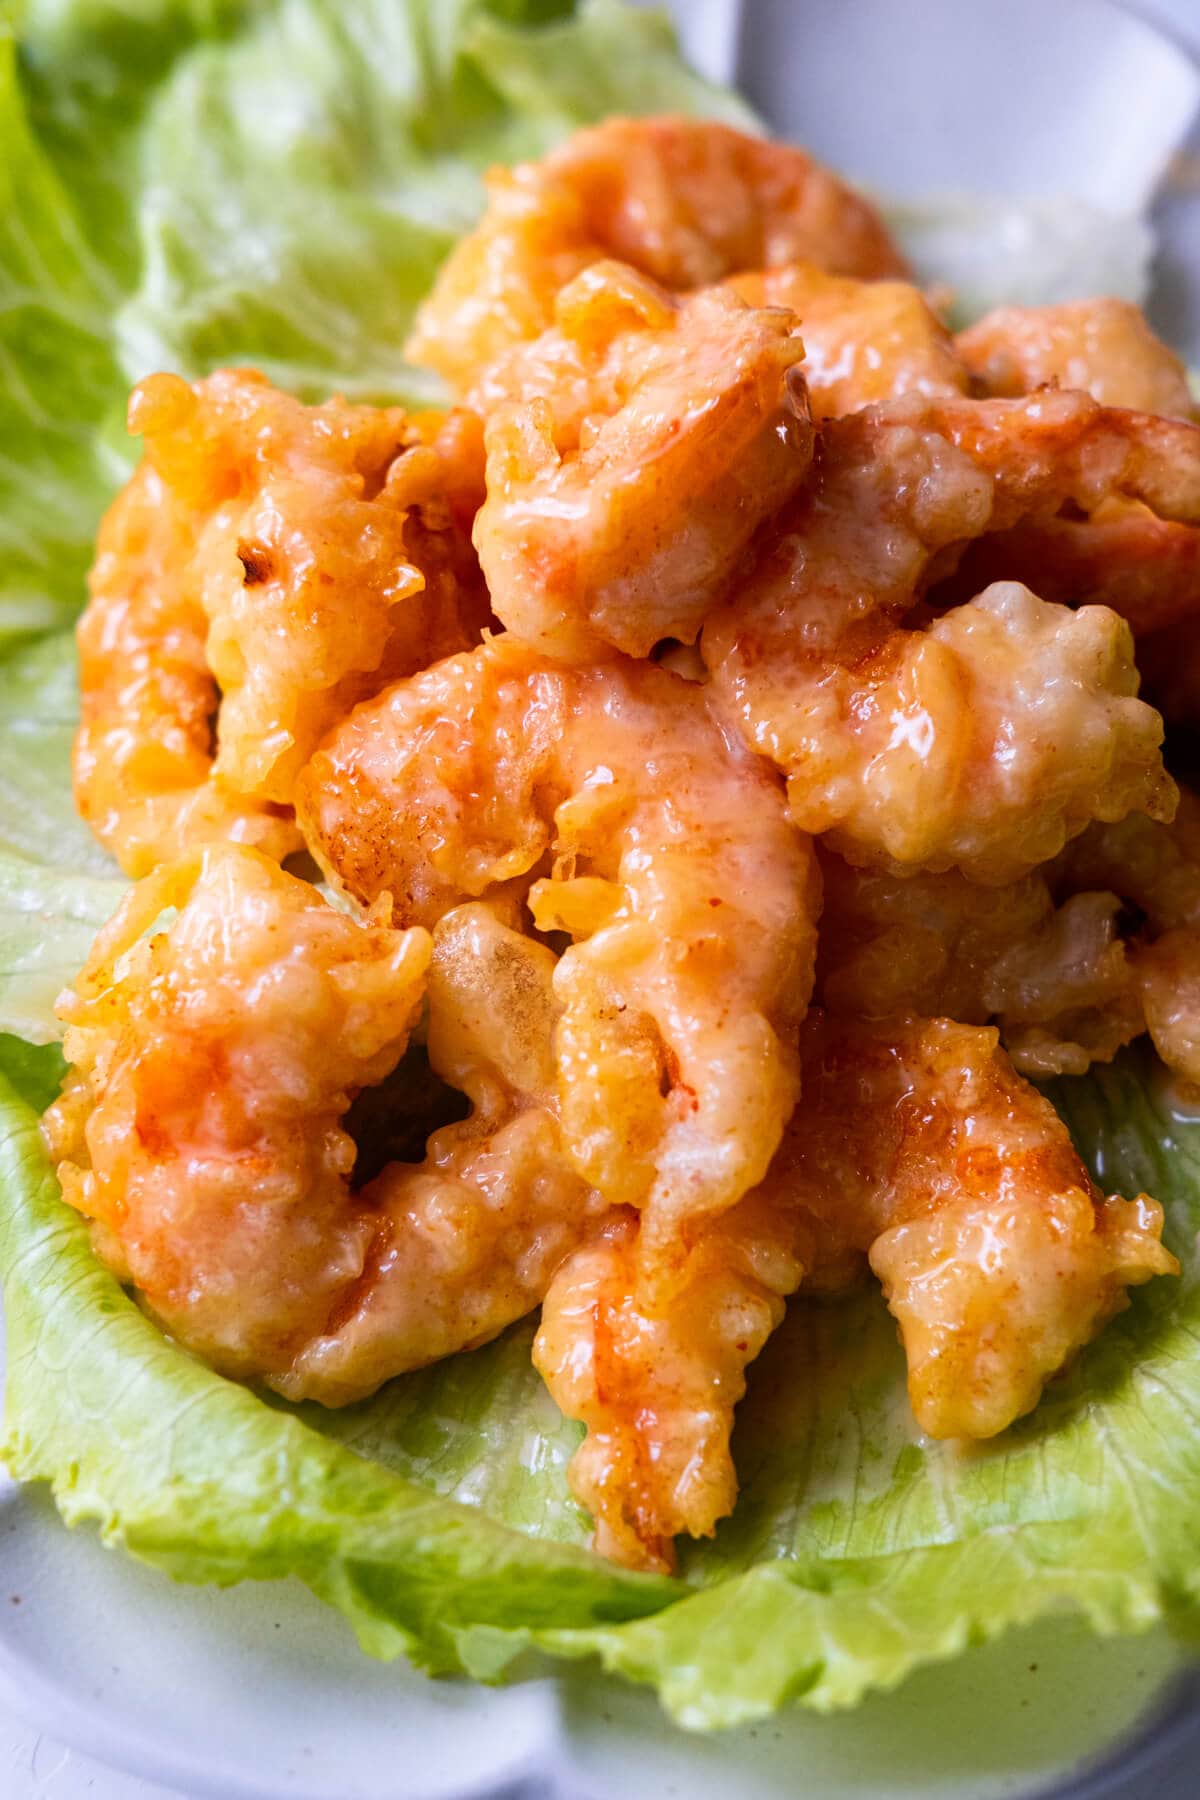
[45,846,601,1404]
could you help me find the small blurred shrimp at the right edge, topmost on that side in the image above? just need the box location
[954,299,1193,419]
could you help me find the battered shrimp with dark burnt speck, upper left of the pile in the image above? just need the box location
[76,371,488,875]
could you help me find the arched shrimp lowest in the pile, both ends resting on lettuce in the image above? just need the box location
[534,1012,1177,1568]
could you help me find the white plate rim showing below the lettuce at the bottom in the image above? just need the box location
[0,1454,1191,1800]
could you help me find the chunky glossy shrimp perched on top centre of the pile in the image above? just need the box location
[473,263,813,661]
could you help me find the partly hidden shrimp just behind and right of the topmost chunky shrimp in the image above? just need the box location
[727,263,968,419]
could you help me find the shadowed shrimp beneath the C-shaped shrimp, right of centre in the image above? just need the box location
[817,851,1146,1078]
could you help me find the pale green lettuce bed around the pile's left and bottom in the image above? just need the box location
[0,0,1200,1726]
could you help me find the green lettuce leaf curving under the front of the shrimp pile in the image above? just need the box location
[0,1039,1200,1728]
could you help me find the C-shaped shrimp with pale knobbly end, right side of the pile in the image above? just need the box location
[700,394,1200,882]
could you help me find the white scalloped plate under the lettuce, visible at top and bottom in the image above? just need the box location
[0,0,1200,1800]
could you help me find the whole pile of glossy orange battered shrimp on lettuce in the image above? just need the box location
[45,117,1200,1568]
